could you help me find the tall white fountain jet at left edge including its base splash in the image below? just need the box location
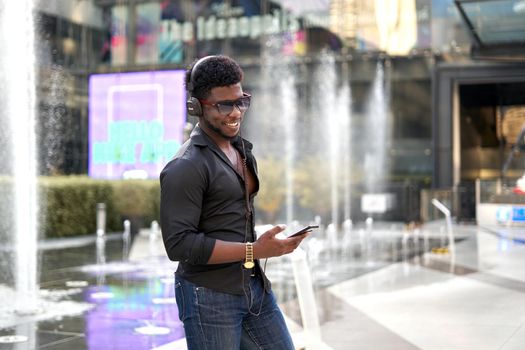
[0,0,95,336]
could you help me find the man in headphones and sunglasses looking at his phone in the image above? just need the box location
[160,56,306,350]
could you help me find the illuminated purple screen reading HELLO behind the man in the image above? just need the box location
[89,70,186,179]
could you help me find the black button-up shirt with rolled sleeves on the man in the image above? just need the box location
[160,125,270,294]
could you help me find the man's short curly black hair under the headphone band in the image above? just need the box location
[185,55,244,99]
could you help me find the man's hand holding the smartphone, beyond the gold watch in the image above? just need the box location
[253,225,309,259]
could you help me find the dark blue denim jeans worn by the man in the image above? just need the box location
[175,276,294,350]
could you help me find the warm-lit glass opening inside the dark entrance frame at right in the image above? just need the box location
[458,82,525,182]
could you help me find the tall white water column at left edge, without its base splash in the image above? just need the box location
[0,0,38,314]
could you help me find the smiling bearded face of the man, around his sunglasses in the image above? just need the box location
[201,83,244,140]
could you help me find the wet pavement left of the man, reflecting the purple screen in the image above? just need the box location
[0,234,184,350]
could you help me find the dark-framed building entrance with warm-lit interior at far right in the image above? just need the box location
[433,62,525,221]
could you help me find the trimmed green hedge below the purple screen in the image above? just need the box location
[0,176,160,238]
